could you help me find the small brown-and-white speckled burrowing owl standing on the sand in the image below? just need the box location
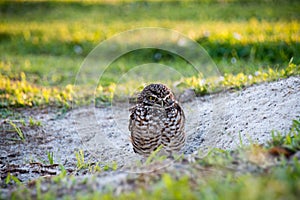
[129,84,186,156]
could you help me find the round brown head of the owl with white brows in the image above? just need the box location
[138,84,175,108]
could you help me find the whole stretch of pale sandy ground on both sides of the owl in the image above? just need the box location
[0,77,300,186]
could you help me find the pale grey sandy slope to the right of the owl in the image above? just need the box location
[184,77,300,151]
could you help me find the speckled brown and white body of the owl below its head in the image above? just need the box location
[128,103,185,155]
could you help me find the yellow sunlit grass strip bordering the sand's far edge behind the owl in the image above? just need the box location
[0,63,300,107]
